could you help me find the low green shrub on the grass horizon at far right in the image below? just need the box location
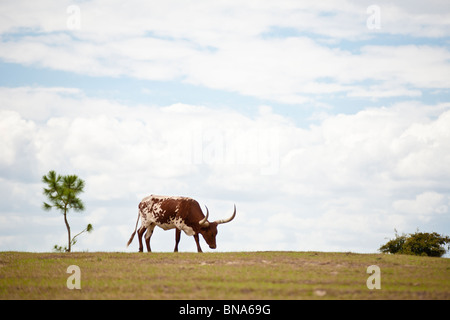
[378,230,450,257]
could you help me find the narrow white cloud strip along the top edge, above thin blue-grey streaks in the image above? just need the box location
[0,0,449,39]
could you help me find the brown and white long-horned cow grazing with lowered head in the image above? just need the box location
[127,195,236,252]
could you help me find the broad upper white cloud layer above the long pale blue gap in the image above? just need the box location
[0,1,450,104]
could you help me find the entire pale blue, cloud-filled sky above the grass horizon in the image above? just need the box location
[0,0,450,252]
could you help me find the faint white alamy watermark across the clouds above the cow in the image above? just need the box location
[160,127,280,175]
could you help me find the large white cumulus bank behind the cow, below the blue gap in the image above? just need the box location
[0,88,450,251]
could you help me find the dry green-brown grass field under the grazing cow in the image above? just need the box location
[0,252,450,300]
